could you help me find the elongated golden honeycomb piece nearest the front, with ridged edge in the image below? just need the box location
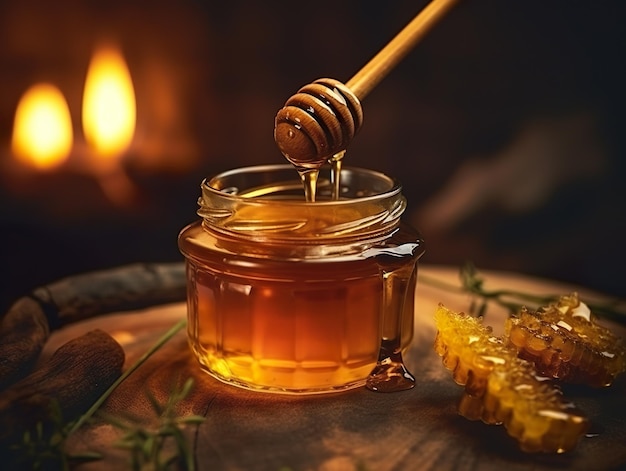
[435,304,588,453]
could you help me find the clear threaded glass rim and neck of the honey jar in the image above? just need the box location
[198,164,406,244]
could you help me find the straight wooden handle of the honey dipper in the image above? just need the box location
[346,0,458,100]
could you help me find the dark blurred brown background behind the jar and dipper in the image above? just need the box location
[0,0,626,316]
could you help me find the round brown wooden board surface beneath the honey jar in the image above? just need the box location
[41,266,626,471]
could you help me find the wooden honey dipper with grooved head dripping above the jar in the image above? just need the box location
[274,0,457,171]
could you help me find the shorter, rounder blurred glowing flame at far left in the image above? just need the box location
[11,83,73,170]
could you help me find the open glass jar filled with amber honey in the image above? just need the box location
[178,165,424,393]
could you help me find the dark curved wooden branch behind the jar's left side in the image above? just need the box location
[0,262,187,390]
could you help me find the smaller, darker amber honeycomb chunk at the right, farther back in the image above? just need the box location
[505,293,626,387]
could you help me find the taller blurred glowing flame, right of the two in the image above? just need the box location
[82,46,137,160]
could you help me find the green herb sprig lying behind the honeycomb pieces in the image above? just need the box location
[420,262,626,325]
